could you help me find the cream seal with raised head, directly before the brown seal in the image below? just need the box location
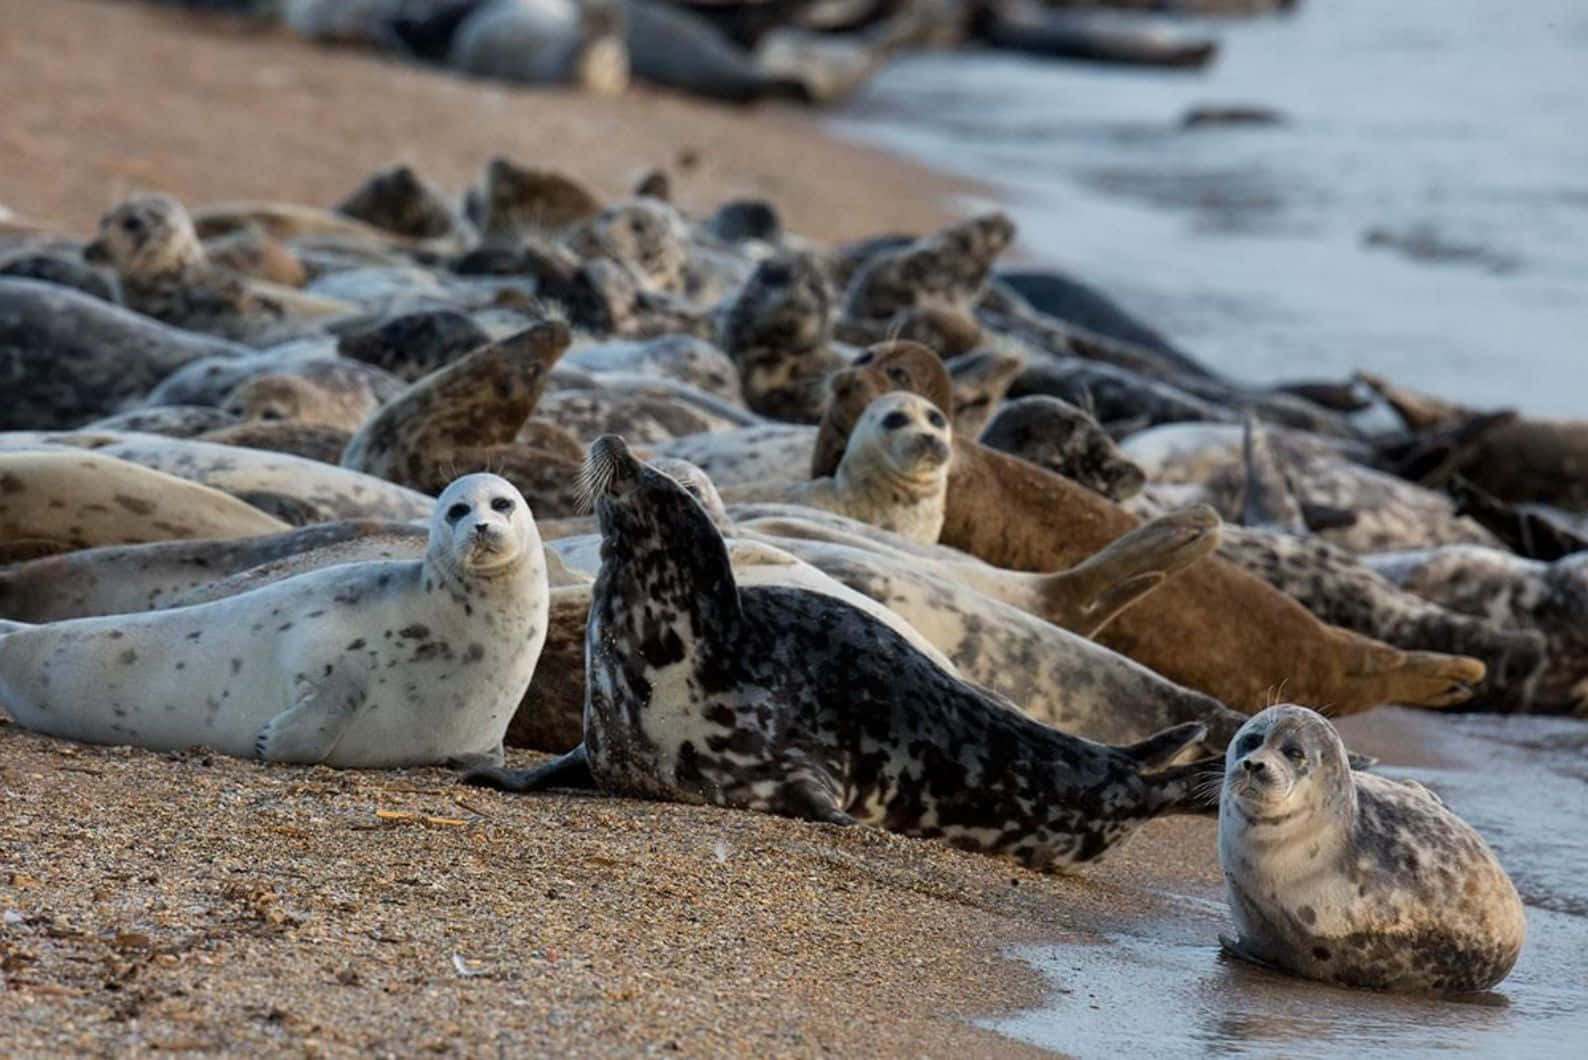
[784,390,953,541]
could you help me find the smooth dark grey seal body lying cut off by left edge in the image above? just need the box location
[0,276,246,430]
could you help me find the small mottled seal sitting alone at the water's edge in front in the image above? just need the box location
[1218,706,1526,993]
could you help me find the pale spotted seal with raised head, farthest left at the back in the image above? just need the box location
[83,195,353,344]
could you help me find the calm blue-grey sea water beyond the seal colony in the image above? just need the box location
[837,0,1588,416]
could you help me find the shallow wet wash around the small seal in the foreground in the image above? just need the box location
[985,711,1588,1057]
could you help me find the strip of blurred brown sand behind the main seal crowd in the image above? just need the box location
[0,0,967,240]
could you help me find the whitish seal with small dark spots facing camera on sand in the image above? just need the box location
[0,474,548,768]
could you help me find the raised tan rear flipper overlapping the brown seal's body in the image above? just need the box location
[1039,505,1221,638]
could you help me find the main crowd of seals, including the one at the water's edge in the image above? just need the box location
[0,153,1549,992]
